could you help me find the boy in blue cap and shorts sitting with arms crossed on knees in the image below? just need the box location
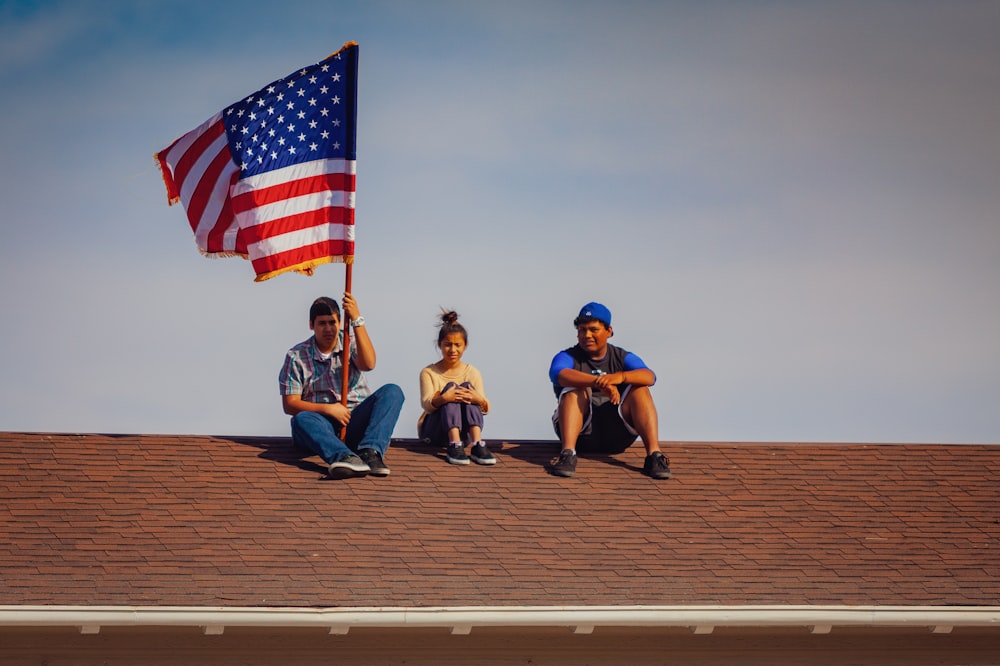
[549,303,670,479]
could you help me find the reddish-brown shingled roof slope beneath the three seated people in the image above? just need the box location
[0,433,1000,607]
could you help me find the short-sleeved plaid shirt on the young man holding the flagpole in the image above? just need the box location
[278,331,371,409]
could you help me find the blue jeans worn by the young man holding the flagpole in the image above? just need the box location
[292,384,403,464]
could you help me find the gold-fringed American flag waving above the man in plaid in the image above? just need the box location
[156,42,358,282]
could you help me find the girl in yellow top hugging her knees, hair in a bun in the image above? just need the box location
[417,312,497,465]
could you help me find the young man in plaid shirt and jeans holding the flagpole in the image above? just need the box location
[278,293,403,479]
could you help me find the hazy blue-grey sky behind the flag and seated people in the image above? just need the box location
[0,0,1000,443]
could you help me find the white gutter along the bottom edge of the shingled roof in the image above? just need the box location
[0,606,1000,634]
